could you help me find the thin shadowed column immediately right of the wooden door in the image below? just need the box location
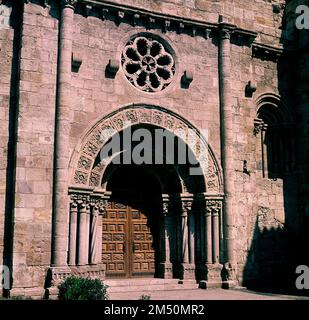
[160,195,173,279]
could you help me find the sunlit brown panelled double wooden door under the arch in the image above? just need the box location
[102,202,155,278]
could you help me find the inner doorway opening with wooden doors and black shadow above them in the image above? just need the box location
[102,165,162,278]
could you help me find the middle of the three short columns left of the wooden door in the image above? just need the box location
[77,201,90,266]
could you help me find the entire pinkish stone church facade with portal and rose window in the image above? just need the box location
[0,0,309,297]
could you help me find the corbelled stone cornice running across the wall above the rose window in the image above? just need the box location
[24,0,285,62]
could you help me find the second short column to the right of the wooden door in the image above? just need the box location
[180,196,195,280]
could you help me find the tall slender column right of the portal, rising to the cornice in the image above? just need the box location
[219,21,235,268]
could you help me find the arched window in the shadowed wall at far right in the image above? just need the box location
[254,95,295,179]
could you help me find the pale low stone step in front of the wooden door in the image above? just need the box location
[104,279,198,293]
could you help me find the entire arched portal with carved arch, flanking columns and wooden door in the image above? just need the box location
[68,105,224,279]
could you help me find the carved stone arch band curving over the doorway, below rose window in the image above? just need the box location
[71,105,222,194]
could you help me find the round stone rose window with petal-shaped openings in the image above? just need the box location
[122,37,175,92]
